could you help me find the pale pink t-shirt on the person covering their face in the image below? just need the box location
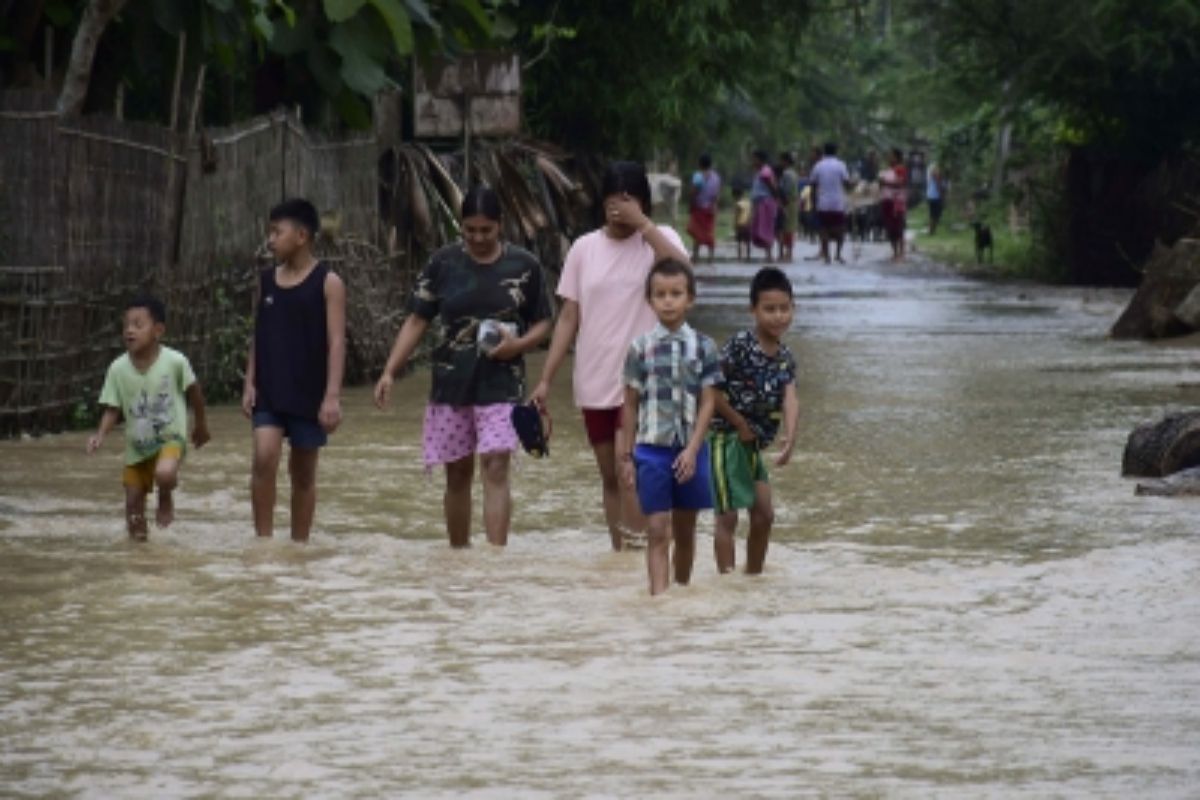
[558,225,688,408]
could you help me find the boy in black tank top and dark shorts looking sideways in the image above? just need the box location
[241,199,346,542]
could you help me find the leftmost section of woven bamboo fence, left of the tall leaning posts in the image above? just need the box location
[0,94,184,432]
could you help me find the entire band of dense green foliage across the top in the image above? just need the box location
[0,0,1200,282]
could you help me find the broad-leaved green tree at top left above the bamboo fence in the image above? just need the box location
[0,0,496,127]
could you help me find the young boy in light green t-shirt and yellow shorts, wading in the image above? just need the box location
[88,296,209,540]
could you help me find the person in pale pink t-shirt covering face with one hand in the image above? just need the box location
[532,161,690,551]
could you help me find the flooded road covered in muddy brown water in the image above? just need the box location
[0,247,1200,799]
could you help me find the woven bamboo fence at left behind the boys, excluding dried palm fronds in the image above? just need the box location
[0,92,380,435]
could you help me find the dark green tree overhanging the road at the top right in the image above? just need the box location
[904,0,1200,283]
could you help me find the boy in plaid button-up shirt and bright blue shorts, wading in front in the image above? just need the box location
[617,259,721,595]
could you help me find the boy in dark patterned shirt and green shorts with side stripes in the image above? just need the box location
[708,266,800,575]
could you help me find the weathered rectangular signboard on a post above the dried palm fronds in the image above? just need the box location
[413,52,521,138]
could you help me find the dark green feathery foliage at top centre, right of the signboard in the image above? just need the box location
[508,0,811,156]
